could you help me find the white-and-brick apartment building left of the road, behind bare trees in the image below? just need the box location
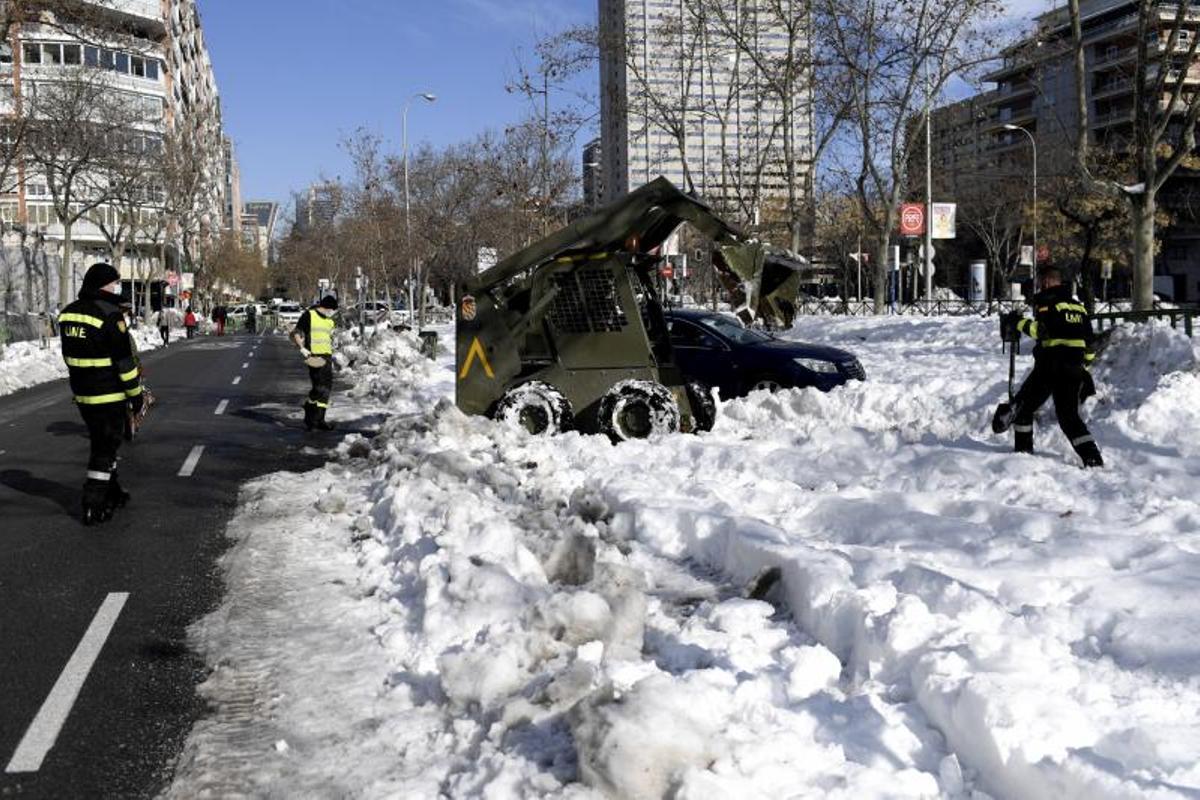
[0,0,230,303]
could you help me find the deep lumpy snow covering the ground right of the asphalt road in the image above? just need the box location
[168,317,1200,800]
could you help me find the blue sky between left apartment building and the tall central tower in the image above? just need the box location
[206,0,596,212]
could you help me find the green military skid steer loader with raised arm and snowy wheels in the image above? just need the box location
[456,178,804,440]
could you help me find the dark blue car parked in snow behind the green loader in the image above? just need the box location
[665,308,866,399]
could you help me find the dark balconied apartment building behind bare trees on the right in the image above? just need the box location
[922,0,1200,302]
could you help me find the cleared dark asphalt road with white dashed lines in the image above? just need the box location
[0,328,336,798]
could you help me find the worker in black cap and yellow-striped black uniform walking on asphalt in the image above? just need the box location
[59,264,143,525]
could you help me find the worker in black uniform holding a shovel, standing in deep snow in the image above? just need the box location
[1001,267,1104,467]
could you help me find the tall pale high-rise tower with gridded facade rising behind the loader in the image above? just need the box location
[600,0,812,215]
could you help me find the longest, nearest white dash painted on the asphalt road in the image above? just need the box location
[5,591,130,772]
